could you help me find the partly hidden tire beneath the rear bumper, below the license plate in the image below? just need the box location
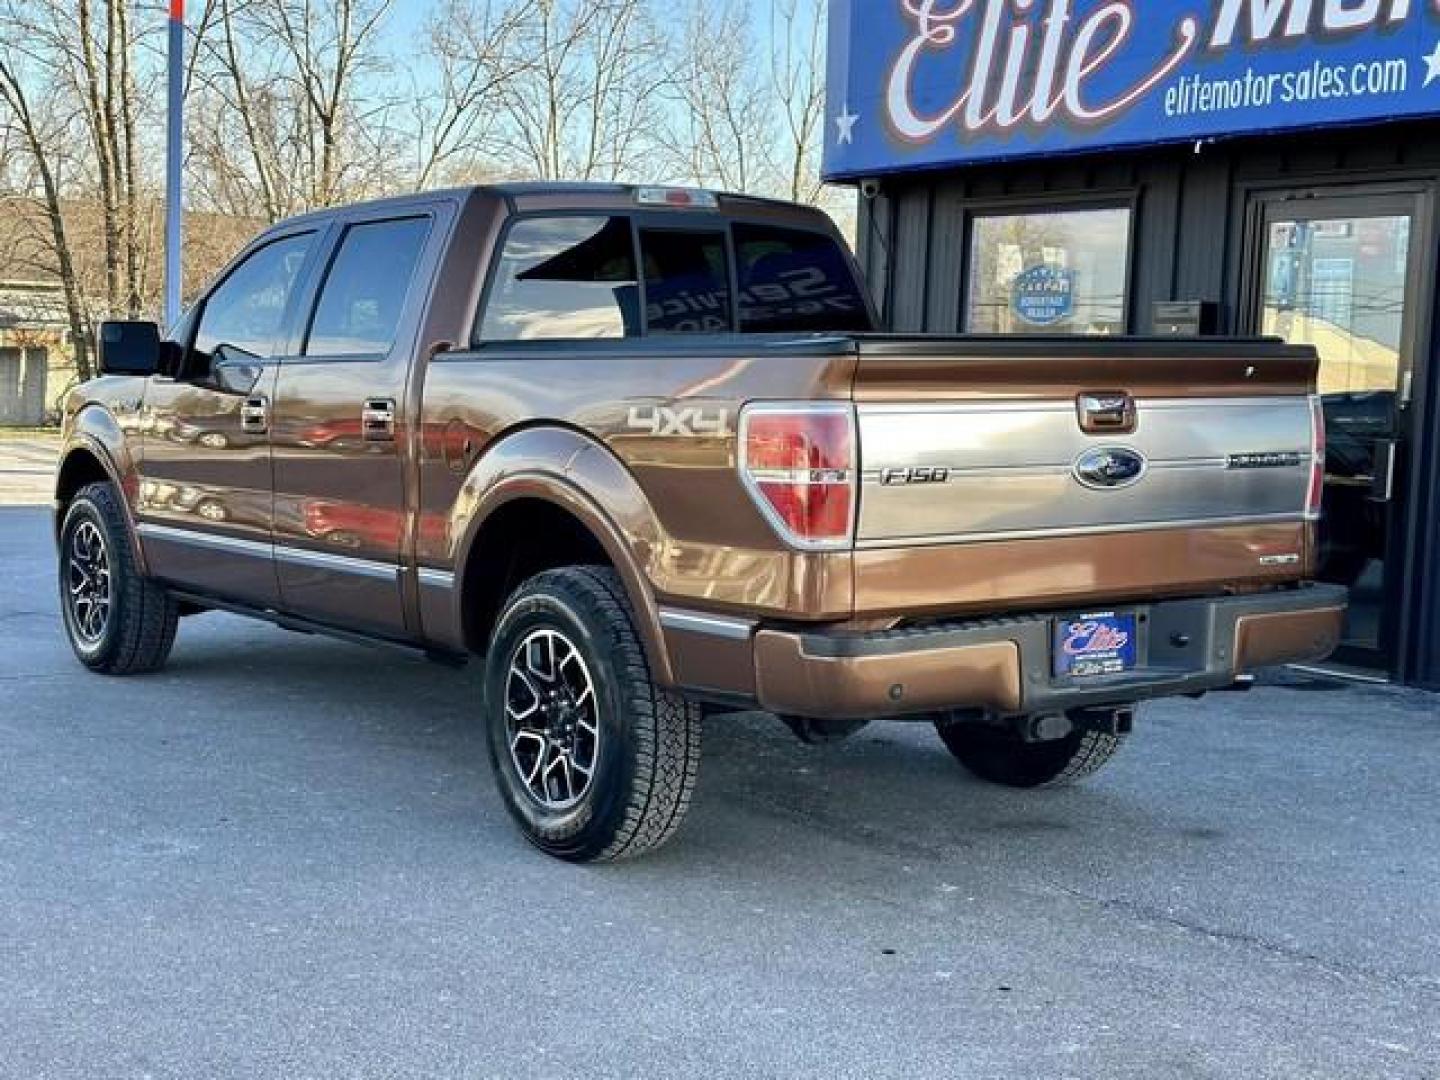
[935,719,1125,788]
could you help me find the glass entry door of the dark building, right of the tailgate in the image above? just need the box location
[1251,194,1424,668]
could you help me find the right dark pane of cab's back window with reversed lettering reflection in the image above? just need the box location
[734,223,874,334]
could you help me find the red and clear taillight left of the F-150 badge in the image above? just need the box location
[740,405,855,549]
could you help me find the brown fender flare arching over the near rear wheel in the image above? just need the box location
[449,425,674,687]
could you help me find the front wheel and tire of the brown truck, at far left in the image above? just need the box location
[59,482,180,675]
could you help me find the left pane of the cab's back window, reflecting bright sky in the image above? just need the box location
[480,217,639,341]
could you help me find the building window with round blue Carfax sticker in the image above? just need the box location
[965,209,1130,334]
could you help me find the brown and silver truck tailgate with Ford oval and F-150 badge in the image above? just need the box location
[854,337,1316,613]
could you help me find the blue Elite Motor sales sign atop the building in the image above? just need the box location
[825,0,1440,179]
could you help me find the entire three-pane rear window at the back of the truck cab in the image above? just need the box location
[475,213,874,344]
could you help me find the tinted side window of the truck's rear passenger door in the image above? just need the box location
[305,217,431,357]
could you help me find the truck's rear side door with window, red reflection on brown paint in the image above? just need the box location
[271,207,444,638]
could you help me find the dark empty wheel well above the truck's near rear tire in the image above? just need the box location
[461,498,612,654]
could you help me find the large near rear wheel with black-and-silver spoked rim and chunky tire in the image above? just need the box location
[485,566,701,863]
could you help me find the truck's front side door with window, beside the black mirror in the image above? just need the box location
[137,229,318,606]
